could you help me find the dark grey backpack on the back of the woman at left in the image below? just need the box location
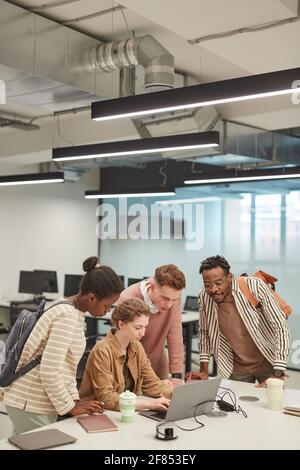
[0,300,72,387]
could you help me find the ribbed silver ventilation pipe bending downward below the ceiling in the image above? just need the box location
[96,35,175,91]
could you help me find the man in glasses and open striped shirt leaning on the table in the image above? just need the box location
[187,256,290,386]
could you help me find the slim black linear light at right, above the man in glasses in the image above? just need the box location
[184,166,300,185]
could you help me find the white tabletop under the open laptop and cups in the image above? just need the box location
[0,380,300,455]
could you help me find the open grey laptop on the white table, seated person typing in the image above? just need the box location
[139,377,221,421]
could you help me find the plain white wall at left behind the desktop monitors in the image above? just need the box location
[0,170,99,299]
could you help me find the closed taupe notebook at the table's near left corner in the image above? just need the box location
[8,429,77,450]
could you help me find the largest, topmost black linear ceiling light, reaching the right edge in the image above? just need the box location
[92,68,300,121]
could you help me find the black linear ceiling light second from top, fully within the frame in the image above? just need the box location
[52,131,219,161]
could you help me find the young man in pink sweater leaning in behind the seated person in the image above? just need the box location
[114,264,185,384]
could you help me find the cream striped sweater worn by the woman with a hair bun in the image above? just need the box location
[3,304,86,415]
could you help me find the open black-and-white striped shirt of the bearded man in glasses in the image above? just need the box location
[199,277,290,378]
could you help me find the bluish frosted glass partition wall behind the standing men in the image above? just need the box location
[97,182,300,369]
